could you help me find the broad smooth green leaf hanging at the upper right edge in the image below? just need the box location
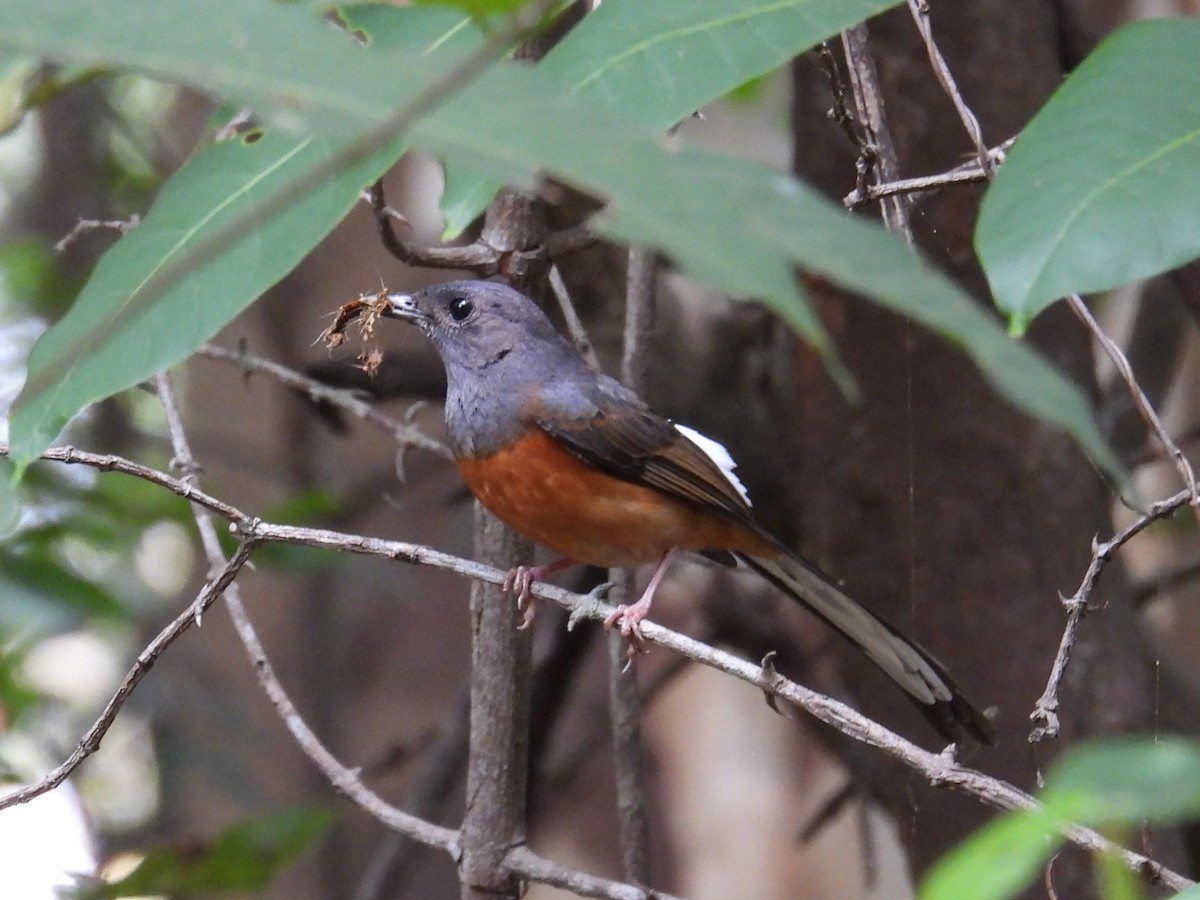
[976,19,1200,329]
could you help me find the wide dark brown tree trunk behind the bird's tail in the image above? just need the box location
[784,1,1152,896]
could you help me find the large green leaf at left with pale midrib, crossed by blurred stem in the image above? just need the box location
[11,131,397,480]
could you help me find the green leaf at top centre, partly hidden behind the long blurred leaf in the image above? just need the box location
[442,0,896,236]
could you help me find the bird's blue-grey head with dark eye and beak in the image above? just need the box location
[385,281,574,377]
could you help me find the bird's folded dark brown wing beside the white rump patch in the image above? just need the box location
[533,379,757,530]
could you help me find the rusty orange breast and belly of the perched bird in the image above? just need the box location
[456,428,778,566]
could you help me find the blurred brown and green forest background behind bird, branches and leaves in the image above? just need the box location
[0,0,1200,900]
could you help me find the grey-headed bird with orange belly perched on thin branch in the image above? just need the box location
[380,280,994,744]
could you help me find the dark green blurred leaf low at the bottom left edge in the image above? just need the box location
[79,806,334,900]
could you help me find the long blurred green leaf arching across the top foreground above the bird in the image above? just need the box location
[0,0,1115,480]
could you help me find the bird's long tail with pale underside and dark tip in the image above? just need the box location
[734,553,995,744]
